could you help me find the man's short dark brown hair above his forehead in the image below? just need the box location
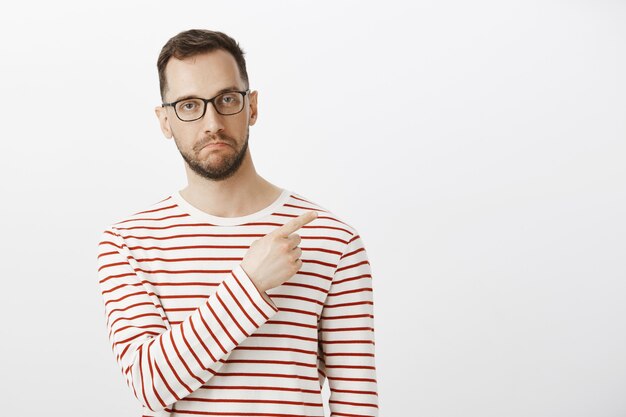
[157,29,249,99]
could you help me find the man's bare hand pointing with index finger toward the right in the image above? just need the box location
[241,211,317,293]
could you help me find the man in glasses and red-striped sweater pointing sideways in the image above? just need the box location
[98,30,378,416]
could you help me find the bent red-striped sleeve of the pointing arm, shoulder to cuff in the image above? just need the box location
[98,227,278,411]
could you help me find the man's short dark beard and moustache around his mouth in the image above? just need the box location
[172,127,250,181]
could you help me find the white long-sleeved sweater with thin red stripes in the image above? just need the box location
[97,189,378,417]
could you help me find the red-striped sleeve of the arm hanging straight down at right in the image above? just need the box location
[318,233,378,417]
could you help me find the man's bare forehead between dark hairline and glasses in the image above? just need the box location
[165,49,244,99]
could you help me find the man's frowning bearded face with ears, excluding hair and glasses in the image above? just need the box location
[155,49,258,181]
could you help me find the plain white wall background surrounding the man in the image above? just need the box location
[0,0,626,417]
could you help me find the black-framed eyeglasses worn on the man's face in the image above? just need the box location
[161,89,250,122]
